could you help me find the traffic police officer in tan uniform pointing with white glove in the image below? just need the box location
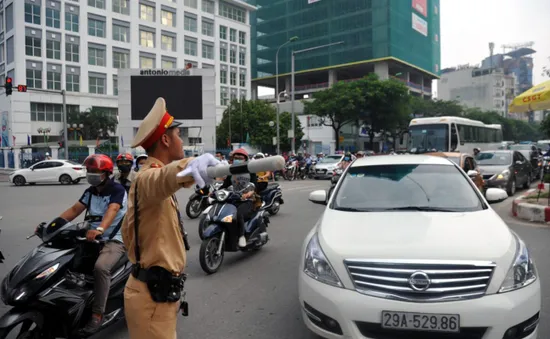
[122,98,219,339]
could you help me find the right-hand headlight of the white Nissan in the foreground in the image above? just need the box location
[498,234,537,293]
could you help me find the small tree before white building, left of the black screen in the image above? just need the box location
[67,107,118,140]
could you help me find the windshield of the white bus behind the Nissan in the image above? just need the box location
[409,124,449,153]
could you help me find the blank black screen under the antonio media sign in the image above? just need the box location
[130,75,202,120]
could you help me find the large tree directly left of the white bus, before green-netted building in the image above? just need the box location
[354,74,411,148]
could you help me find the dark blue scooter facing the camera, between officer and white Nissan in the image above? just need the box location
[199,185,269,274]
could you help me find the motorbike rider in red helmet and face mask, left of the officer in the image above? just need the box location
[56,154,127,334]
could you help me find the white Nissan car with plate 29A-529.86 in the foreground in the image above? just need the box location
[298,155,541,339]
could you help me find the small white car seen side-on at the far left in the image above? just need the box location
[9,159,86,186]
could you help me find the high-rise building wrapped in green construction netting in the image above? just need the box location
[247,0,440,153]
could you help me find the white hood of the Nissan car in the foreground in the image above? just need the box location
[318,208,516,265]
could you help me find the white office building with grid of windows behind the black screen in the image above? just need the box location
[0,0,254,150]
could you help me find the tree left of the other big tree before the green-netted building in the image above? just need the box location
[304,81,362,149]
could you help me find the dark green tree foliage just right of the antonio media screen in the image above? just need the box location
[216,100,304,149]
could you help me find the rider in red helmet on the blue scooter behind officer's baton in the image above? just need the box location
[221,148,257,247]
